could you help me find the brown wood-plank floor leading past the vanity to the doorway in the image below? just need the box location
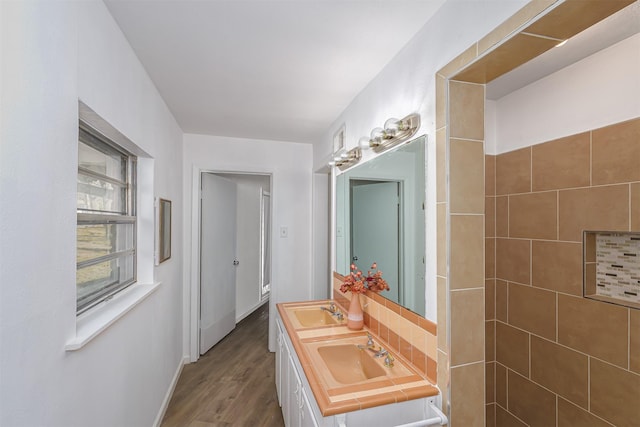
[161,303,284,427]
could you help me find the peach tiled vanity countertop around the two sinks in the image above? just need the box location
[277,300,438,416]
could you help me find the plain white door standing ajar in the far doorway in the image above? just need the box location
[200,173,237,354]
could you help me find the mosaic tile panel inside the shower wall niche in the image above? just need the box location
[596,233,640,304]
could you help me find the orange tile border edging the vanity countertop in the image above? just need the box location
[276,299,439,417]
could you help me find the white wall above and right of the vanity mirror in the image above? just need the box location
[314,0,527,321]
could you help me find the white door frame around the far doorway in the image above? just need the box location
[188,165,277,363]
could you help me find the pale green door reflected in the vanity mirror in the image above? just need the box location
[349,180,403,303]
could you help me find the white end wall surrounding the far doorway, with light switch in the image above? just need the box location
[183,134,313,354]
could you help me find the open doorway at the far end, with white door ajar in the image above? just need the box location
[191,171,271,361]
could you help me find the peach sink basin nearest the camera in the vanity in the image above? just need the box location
[318,344,387,384]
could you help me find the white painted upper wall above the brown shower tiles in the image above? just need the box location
[487,34,640,154]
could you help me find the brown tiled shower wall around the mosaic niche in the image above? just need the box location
[485,118,640,427]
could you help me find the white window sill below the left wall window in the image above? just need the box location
[65,282,160,351]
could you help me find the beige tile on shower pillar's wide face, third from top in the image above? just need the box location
[449,215,484,289]
